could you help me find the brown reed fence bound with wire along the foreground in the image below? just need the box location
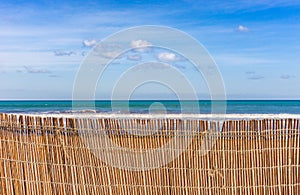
[0,114,300,194]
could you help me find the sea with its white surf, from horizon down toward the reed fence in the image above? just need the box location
[0,100,300,118]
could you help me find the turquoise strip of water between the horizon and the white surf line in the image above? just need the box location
[0,100,300,114]
